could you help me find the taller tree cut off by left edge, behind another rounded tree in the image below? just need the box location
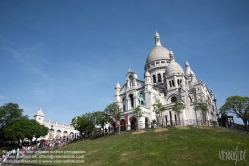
[0,102,28,140]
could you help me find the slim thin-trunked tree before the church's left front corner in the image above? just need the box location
[104,102,122,134]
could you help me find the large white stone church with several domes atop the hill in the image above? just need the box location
[113,32,218,130]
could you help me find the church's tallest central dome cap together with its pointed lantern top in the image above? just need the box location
[146,32,170,64]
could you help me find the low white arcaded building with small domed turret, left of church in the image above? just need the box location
[34,108,79,140]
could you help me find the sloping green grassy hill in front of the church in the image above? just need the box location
[28,127,249,166]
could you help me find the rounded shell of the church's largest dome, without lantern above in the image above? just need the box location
[146,46,170,64]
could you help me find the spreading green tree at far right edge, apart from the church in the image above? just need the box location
[219,96,249,127]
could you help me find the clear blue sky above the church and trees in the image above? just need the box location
[0,0,249,124]
